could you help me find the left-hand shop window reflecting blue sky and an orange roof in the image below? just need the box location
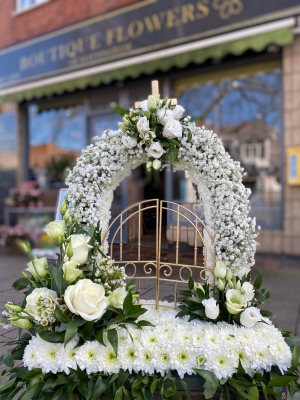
[29,106,87,188]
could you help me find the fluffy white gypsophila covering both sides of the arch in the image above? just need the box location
[67,122,256,277]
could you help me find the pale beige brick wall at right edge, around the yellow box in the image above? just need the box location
[258,36,300,255]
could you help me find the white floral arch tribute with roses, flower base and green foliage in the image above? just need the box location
[0,96,300,400]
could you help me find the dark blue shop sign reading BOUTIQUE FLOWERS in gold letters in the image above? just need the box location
[0,0,300,88]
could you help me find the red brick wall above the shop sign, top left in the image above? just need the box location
[0,0,139,49]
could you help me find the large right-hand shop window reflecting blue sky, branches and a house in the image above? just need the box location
[174,69,282,229]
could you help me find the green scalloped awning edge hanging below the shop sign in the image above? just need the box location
[0,27,294,103]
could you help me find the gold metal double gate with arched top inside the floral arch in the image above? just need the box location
[104,199,215,308]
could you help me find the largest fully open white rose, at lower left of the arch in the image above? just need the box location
[64,279,109,321]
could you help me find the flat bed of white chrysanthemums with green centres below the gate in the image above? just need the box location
[23,303,292,379]
